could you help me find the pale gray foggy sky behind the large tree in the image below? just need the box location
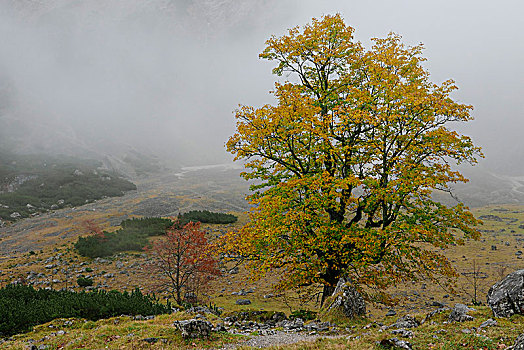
[0,0,524,172]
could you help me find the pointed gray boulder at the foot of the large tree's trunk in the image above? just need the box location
[328,278,366,318]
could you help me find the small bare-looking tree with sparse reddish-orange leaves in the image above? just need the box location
[145,222,220,305]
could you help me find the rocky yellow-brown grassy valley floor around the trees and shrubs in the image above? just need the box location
[0,166,524,349]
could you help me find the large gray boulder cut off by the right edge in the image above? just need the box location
[487,269,524,317]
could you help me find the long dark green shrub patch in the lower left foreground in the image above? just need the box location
[0,285,171,337]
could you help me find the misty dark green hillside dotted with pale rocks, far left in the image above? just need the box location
[0,153,136,221]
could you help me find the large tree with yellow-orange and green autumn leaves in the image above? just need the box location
[227,14,482,304]
